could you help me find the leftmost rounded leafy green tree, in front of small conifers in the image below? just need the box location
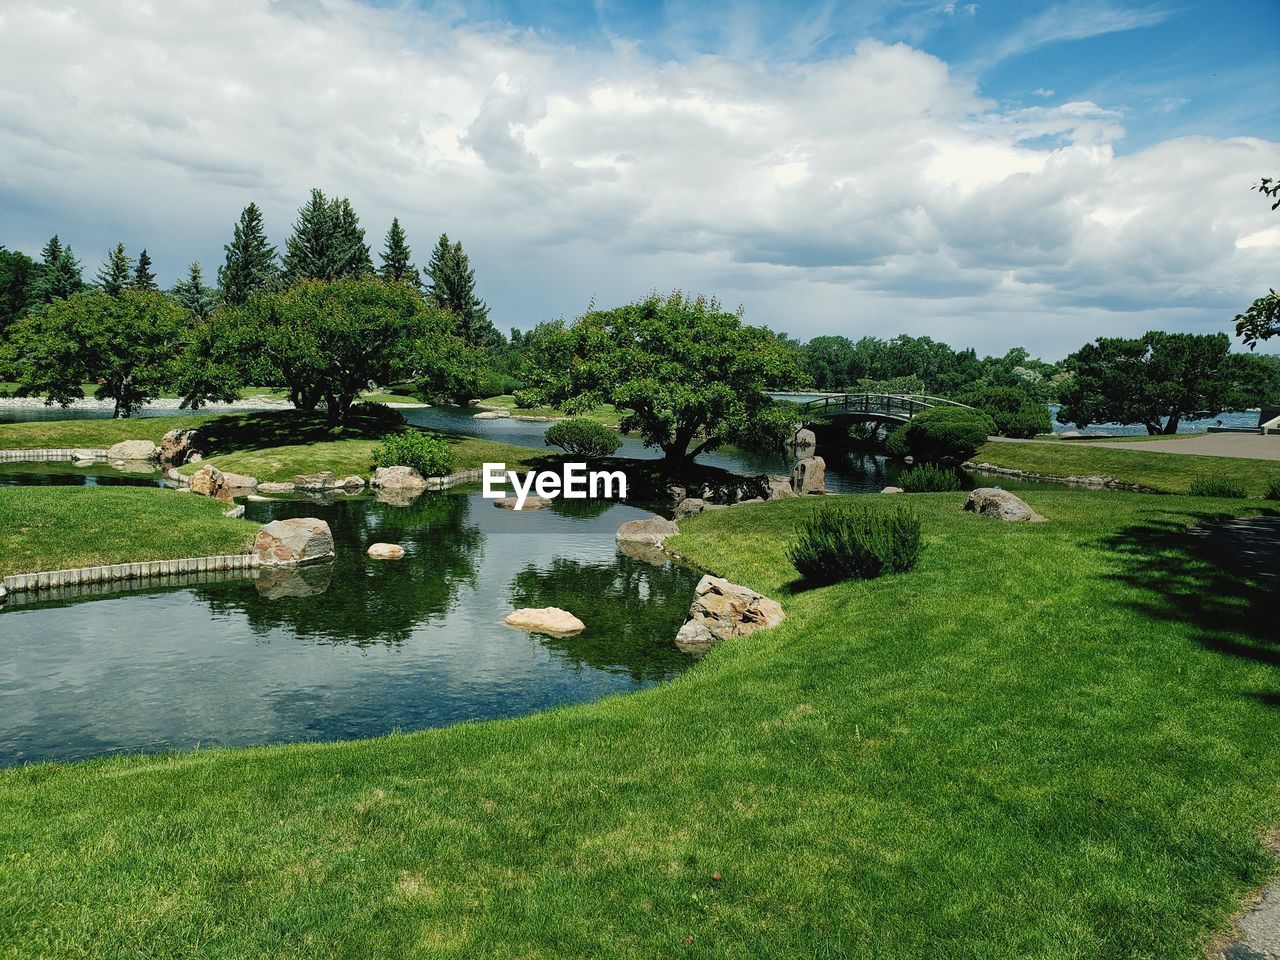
[5,289,187,417]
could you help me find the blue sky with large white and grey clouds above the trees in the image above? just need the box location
[0,0,1280,360]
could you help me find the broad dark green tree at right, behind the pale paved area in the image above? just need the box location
[1057,330,1258,435]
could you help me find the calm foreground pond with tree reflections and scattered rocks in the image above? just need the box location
[0,478,700,765]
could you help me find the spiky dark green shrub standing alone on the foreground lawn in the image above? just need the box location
[787,504,920,584]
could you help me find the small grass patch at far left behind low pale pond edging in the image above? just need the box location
[0,486,257,578]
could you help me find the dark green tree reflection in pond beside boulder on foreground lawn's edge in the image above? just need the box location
[511,554,699,682]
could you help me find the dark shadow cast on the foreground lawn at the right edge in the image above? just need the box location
[1102,511,1280,707]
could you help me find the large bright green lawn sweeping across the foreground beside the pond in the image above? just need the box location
[0,490,1280,960]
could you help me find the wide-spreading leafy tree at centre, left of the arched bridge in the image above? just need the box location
[529,291,795,468]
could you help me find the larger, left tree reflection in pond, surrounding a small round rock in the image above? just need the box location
[196,493,484,645]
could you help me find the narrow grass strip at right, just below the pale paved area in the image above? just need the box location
[973,440,1280,497]
